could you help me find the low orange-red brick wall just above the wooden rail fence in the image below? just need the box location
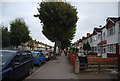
[88,57,118,63]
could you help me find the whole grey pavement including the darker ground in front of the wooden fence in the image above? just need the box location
[26,54,111,81]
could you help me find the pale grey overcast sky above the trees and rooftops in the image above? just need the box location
[0,2,118,45]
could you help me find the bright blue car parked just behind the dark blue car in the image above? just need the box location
[32,52,45,67]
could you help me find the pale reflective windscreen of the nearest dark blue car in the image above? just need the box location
[0,51,15,65]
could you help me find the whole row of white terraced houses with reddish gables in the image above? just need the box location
[73,17,120,58]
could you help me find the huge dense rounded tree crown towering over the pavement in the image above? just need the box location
[34,2,78,58]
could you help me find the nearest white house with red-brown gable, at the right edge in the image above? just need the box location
[105,17,120,57]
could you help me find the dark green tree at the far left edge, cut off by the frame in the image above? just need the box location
[1,26,11,48]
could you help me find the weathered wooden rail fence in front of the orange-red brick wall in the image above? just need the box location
[80,62,118,72]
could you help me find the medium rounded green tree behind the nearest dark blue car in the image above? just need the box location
[10,18,31,47]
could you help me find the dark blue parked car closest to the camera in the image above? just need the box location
[0,50,33,81]
